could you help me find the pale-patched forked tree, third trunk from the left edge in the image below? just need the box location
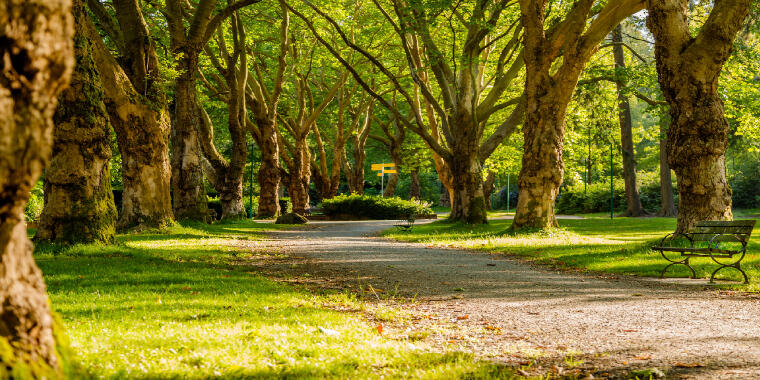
[86,0,174,229]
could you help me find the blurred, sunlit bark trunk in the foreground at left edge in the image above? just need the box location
[0,0,74,378]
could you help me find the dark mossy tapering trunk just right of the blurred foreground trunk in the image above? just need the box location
[35,6,116,244]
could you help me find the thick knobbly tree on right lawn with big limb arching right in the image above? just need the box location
[511,0,644,230]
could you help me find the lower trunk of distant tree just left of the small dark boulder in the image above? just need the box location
[257,120,280,218]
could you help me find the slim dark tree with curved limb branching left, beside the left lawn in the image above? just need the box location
[196,12,248,220]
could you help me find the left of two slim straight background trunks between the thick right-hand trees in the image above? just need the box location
[612,24,646,217]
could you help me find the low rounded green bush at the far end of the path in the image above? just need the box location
[322,194,433,219]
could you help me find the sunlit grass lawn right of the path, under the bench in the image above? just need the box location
[384,215,760,291]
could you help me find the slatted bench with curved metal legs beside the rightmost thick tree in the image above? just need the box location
[652,220,755,284]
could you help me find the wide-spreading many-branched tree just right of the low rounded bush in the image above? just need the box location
[291,0,524,223]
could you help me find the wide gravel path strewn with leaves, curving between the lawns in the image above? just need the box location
[254,221,760,379]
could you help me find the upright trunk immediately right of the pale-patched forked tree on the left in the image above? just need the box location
[172,56,208,221]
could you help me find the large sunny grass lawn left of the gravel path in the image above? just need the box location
[35,221,510,379]
